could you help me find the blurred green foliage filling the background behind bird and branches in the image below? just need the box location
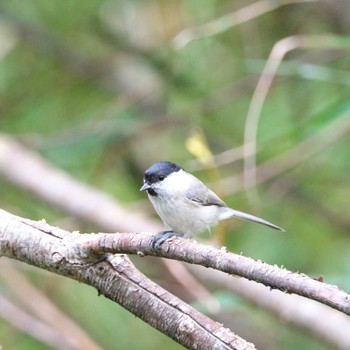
[0,0,350,349]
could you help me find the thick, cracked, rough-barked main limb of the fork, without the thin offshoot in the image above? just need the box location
[0,210,255,350]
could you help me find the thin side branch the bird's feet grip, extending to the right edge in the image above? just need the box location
[80,233,350,315]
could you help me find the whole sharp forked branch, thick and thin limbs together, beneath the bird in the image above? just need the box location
[0,210,350,349]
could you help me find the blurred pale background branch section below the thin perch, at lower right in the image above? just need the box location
[187,265,350,350]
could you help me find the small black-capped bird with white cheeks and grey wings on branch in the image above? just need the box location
[140,161,284,248]
